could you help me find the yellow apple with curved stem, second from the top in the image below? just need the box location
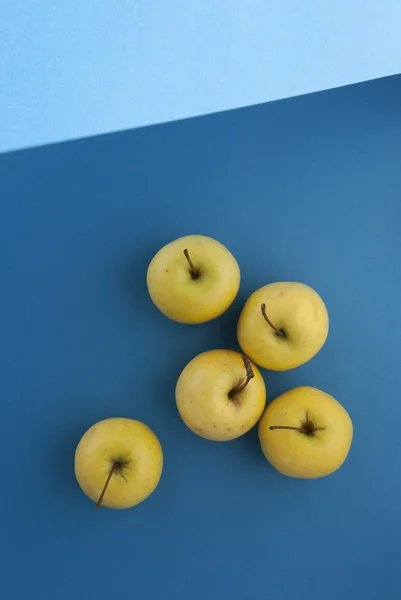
[237,281,329,371]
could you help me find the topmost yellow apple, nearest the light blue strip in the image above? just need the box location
[147,235,240,323]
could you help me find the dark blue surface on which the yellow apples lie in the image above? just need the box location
[0,77,401,600]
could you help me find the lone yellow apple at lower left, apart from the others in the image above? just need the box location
[75,417,163,508]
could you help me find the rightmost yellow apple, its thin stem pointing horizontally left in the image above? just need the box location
[259,387,353,479]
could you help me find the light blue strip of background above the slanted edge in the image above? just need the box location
[0,0,401,151]
